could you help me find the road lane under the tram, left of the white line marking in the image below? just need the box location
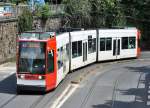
[0,55,103,108]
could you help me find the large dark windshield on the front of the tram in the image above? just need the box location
[18,42,46,74]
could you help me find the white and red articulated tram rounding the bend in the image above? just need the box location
[16,28,140,92]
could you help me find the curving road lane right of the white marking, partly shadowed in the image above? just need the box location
[61,52,150,108]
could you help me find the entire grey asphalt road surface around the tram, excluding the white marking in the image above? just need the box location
[0,52,150,108]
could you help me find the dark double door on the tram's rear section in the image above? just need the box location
[113,38,121,58]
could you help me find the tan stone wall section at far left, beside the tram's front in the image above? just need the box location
[0,20,17,63]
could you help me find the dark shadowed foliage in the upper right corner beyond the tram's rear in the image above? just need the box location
[121,0,150,47]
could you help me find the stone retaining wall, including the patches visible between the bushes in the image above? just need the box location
[0,18,61,63]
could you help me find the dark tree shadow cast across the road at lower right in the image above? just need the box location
[92,66,150,108]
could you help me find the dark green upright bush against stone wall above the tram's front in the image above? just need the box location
[18,9,33,33]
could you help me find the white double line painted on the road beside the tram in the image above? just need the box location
[50,84,78,108]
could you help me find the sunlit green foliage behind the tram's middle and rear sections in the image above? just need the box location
[63,0,126,28]
